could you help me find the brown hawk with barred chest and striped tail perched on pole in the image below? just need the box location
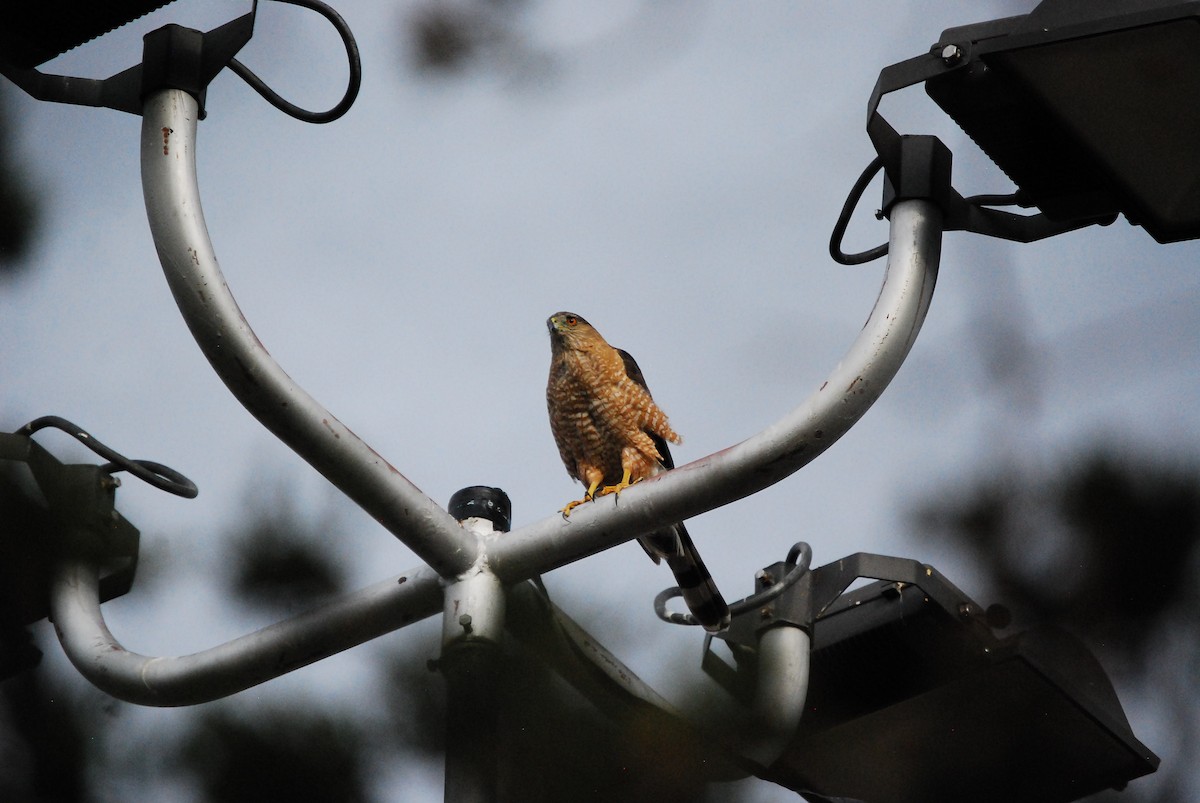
[546,312,730,633]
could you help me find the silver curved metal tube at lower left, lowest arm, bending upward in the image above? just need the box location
[50,558,442,706]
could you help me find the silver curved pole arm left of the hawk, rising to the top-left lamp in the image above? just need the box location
[142,90,479,576]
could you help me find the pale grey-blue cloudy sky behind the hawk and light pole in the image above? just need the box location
[0,0,1200,801]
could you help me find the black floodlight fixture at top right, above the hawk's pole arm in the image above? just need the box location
[868,0,1200,248]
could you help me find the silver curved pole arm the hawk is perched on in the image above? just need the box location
[486,200,942,582]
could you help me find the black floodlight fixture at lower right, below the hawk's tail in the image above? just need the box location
[704,553,1159,803]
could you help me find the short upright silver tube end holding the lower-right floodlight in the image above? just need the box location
[742,625,810,767]
